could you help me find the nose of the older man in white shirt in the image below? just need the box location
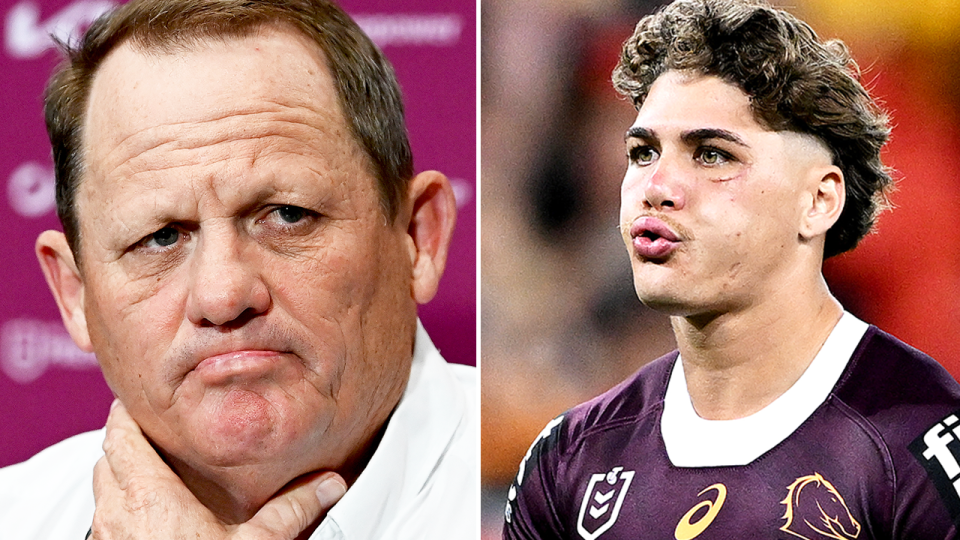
[187,227,270,326]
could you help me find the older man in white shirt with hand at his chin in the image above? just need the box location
[0,0,477,539]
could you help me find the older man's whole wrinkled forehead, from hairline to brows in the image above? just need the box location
[76,23,376,236]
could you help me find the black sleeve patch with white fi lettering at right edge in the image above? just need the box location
[907,411,960,526]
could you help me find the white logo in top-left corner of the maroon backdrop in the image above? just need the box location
[4,0,116,59]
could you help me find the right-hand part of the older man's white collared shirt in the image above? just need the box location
[310,325,480,540]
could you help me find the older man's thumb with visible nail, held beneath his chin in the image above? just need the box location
[235,472,347,540]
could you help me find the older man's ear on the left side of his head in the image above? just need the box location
[35,231,93,352]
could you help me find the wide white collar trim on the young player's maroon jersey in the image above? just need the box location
[660,312,868,467]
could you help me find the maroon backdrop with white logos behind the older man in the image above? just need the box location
[0,0,477,466]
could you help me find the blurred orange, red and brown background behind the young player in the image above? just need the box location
[480,0,960,539]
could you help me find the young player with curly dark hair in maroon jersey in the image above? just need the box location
[504,0,960,540]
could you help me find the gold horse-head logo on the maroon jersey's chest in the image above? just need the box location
[780,473,860,540]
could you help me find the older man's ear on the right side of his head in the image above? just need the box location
[407,171,457,304]
